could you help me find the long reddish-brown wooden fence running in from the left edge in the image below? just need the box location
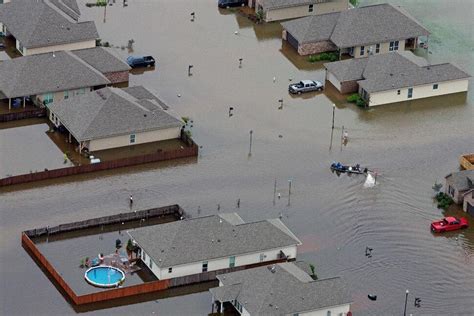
[0,133,199,187]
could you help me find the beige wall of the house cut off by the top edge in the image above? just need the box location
[265,0,348,22]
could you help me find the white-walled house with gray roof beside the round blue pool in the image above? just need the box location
[128,213,301,280]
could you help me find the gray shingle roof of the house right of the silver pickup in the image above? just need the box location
[324,52,470,92]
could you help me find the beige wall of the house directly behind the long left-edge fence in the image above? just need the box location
[89,127,181,151]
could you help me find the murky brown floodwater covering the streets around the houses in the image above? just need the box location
[0,0,474,315]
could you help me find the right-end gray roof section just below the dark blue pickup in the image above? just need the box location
[72,47,130,74]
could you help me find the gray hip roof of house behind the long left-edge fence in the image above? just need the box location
[48,87,183,141]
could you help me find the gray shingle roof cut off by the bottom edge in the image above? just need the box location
[210,262,352,315]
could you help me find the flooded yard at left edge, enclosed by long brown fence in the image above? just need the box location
[0,123,70,178]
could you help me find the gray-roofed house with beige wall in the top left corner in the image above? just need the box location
[0,0,99,56]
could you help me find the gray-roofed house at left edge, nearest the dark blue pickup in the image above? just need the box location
[0,47,130,107]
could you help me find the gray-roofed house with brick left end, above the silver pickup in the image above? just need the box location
[282,3,430,58]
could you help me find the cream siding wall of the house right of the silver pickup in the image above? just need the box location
[369,79,469,106]
